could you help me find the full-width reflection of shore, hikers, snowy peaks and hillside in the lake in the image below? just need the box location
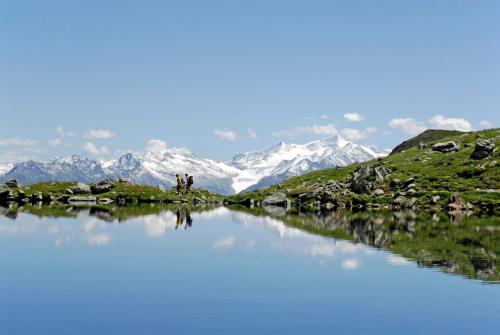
[0,204,500,282]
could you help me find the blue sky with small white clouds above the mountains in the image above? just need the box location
[0,0,500,162]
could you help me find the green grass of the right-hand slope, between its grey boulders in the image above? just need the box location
[226,129,500,213]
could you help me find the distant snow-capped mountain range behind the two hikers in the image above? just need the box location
[0,135,385,194]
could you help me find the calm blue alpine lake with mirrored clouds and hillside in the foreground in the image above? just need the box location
[0,204,500,334]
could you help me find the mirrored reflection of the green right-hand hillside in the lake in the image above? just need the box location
[229,208,500,282]
